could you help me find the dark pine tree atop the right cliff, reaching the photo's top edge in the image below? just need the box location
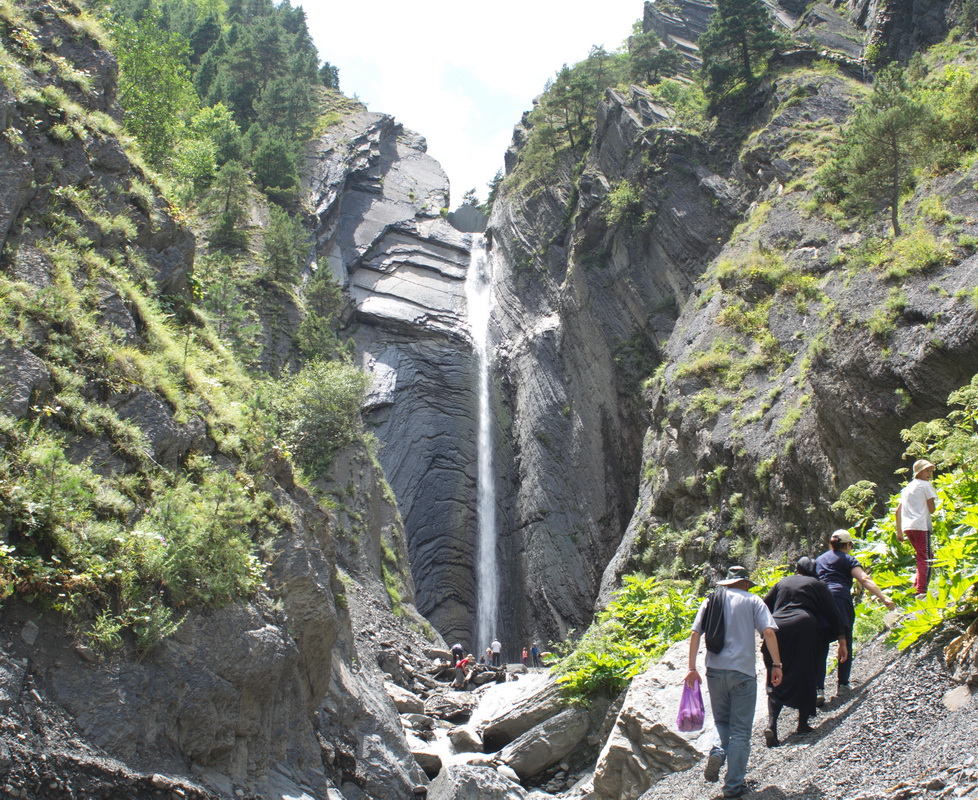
[698,0,782,101]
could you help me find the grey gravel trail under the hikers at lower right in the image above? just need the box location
[641,633,978,800]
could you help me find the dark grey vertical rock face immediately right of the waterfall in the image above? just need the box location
[482,83,742,637]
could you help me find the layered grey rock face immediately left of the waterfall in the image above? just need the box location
[308,112,488,642]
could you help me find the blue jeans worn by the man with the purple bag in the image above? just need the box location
[706,669,757,794]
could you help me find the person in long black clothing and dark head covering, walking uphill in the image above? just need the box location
[761,556,849,747]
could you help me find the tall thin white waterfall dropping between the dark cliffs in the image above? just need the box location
[465,234,499,655]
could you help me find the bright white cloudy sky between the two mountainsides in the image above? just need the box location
[302,0,644,208]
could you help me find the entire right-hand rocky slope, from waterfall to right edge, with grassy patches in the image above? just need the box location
[478,3,978,637]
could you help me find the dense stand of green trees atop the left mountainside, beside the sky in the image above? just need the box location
[95,0,338,203]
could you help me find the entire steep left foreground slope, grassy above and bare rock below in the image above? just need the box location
[0,2,437,800]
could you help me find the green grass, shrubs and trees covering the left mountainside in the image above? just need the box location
[0,0,370,652]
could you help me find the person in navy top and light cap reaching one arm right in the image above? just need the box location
[815,530,896,705]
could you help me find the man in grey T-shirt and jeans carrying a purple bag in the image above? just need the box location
[685,566,781,797]
